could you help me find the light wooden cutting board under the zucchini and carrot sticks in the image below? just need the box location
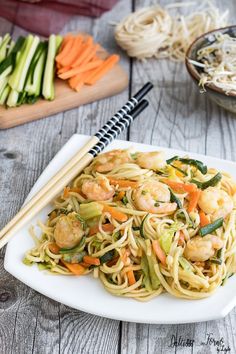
[0,49,128,129]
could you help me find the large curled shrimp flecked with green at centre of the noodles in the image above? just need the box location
[133,180,177,214]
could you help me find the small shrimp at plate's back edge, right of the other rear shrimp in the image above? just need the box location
[136,151,165,170]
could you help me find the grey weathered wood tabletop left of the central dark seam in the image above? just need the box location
[0,0,129,353]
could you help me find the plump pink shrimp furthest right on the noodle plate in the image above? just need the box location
[198,187,234,220]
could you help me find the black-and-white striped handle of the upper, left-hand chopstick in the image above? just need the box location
[95,82,153,140]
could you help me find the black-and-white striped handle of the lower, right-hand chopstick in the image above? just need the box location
[88,99,149,157]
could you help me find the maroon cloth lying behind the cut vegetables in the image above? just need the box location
[0,0,118,36]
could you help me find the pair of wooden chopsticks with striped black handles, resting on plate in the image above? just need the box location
[0,82,153,248]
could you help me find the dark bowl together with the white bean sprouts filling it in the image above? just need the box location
[185,26,236,113]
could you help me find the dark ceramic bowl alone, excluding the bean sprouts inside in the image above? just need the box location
[185,26,236,113]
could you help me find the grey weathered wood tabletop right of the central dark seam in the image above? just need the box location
[121,0,236,354]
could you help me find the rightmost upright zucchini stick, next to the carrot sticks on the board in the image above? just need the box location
[42,34,62,100]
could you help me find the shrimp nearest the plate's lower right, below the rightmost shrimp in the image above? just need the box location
[184,234,223,262]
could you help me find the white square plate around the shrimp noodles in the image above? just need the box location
[4,135,236,324]
